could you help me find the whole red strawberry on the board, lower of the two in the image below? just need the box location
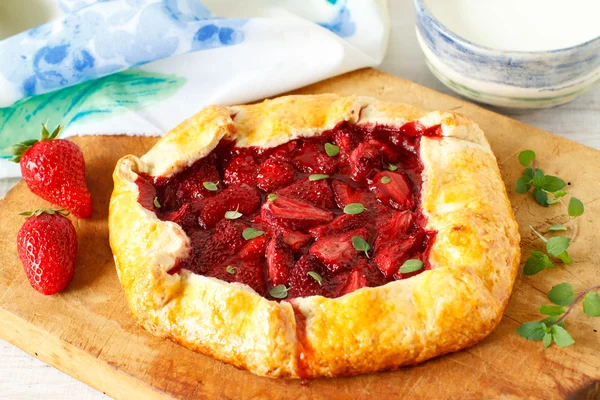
[17,208,77,295]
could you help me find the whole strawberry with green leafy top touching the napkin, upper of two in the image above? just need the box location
[11,124,92,218]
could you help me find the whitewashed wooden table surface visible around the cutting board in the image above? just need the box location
[0,0,600,400]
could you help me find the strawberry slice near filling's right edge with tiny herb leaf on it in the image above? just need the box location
[370,171,412,210]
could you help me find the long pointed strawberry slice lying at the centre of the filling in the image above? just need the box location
[261,196,333,230]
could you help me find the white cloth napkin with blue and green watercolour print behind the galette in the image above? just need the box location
[0,0,389,177]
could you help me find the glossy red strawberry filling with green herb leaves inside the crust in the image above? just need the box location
[136,122,441,300]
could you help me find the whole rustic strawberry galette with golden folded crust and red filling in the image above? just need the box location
[109,94,519,378]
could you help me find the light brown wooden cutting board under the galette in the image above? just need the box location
[0,69,600,400]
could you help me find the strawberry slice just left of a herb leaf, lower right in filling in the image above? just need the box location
[308,228,369,272]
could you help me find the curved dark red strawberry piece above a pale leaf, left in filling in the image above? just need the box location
[199,183,261,228]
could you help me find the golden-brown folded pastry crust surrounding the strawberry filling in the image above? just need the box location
[109,94,520,378]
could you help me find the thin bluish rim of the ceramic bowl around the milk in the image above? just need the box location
[414,0,600,57]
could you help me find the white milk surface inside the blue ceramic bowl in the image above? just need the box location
[424,0,600,51]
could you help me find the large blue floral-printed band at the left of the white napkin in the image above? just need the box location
[0,0,247,106]
